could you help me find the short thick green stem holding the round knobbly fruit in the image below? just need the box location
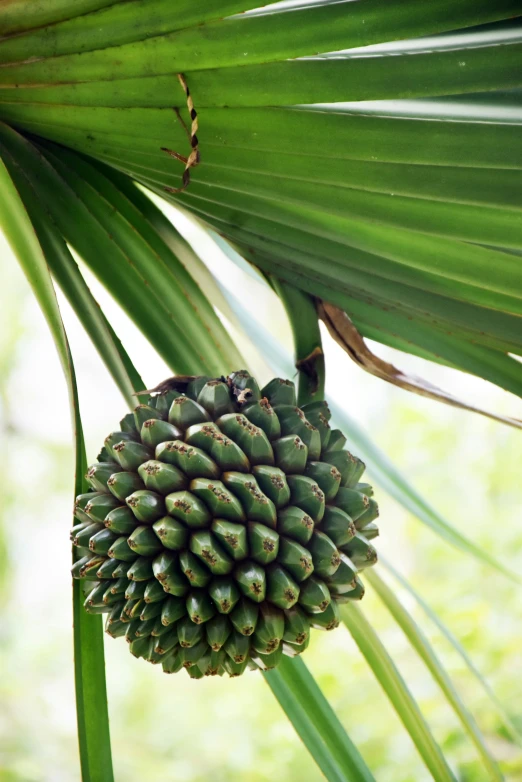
[271,277,325,406]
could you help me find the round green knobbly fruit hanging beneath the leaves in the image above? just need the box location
[71,371,378,679]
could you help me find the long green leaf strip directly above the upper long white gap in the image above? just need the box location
[0,0,520,84]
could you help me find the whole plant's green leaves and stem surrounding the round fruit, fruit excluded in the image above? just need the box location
[0,0,522,782]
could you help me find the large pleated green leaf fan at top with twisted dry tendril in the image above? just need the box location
[0,0,522,394]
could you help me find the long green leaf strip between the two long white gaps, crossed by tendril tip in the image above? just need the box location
[5,40,522,109]
